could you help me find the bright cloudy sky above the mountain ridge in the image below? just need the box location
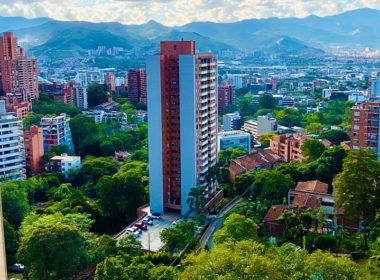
[0,0,380,26]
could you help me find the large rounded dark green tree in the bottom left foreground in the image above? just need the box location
[18,224,86,280]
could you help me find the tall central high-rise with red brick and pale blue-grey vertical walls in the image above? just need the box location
[146,41,218,214]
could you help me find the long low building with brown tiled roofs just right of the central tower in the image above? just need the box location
[228,150,283,183]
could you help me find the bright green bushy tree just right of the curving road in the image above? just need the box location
[213,213,259,244]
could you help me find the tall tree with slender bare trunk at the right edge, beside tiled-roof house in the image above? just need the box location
[335,148,380,249]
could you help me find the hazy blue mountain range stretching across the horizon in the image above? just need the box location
[0,8,380,58]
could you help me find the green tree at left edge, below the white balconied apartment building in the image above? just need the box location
[0,182,30,227]
